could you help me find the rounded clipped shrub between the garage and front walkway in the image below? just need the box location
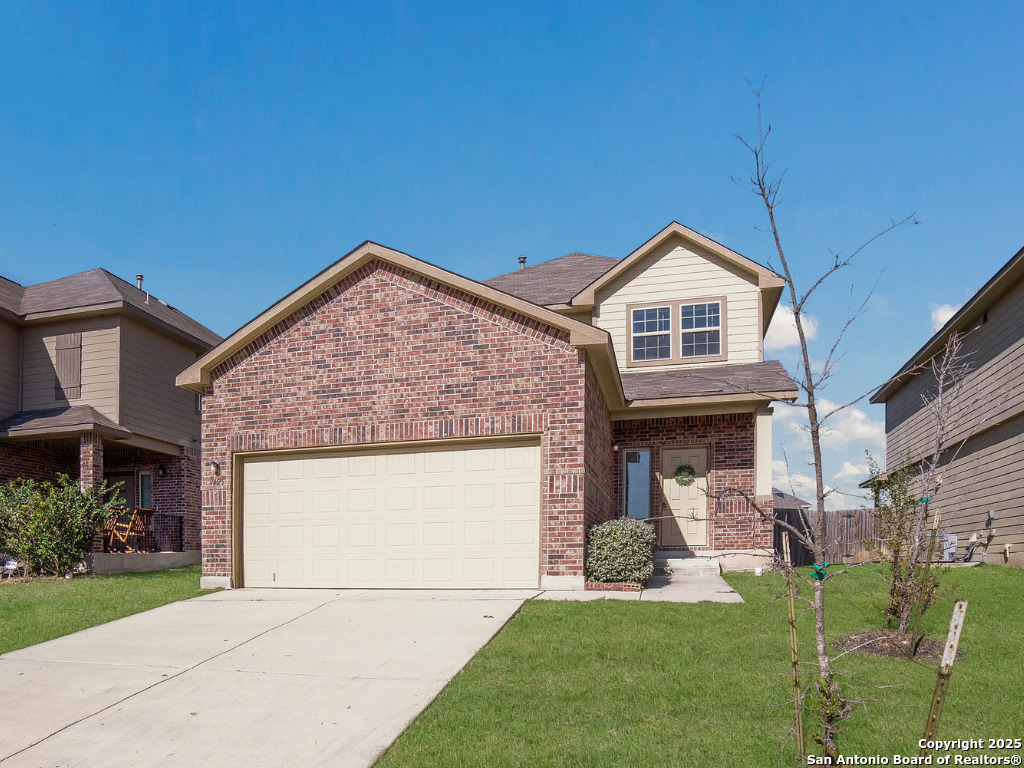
[587,517,657,584]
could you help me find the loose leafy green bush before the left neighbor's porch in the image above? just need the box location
[0,475,124,573]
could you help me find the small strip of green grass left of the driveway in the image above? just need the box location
[0,565,209,653]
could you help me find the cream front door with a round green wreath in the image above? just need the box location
[662,445,708,547]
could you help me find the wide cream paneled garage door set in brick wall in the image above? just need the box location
[242,443,541,589]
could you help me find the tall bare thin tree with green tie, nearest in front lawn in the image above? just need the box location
[736,85,913,759]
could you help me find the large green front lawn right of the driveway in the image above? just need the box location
[377,565,1024,768]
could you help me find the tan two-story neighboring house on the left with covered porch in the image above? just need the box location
[0,269,220,550]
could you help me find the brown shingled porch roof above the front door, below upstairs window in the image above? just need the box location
[622,360,798,400]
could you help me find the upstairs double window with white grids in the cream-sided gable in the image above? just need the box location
[628,297,726,366]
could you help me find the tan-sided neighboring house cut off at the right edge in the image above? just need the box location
[864,243,1024,566]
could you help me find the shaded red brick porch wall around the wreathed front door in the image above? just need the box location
[612,414,772,550]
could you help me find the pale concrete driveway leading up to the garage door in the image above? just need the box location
[0,590,537,768]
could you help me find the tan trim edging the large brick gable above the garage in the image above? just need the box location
[177,241,623,402]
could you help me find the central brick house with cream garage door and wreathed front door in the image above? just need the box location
[178,223,797,589]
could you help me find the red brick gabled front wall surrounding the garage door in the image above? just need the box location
[197,260,601,577]
